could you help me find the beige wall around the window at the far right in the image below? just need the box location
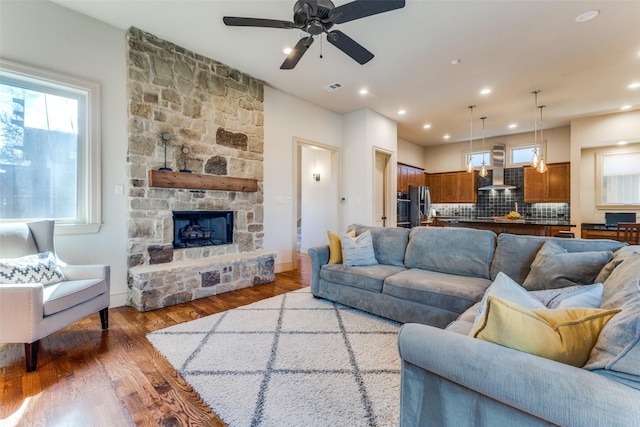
[571,111,640,231]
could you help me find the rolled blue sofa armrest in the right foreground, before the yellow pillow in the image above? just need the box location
[398,324,640,426]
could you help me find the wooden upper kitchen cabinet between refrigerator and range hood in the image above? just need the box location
[426,172,478,203]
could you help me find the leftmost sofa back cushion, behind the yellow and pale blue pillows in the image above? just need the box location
[347,224,410,267]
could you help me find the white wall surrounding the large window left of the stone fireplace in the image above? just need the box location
[0,1,127,306]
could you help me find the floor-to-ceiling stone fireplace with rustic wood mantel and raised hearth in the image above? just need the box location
[127,28,274,311]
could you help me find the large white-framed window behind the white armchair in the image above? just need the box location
[0,60,101,233]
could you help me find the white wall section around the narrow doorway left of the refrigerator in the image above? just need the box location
[342,109,398,225]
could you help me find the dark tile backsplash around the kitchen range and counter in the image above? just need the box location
[433,168,571,220]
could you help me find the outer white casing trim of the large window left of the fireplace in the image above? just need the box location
[0,58,102,235]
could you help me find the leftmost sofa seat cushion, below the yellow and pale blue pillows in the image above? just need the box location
[320,264,405,292]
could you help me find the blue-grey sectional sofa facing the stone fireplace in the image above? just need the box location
[309,226,640,427]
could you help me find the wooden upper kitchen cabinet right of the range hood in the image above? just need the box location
[524,163,571,203]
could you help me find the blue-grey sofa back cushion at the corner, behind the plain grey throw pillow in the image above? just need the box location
[491,233,626,283]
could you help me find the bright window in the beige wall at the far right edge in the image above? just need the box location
[596,149,640,208]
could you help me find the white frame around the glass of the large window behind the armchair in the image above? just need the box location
[0,58,102,234]
